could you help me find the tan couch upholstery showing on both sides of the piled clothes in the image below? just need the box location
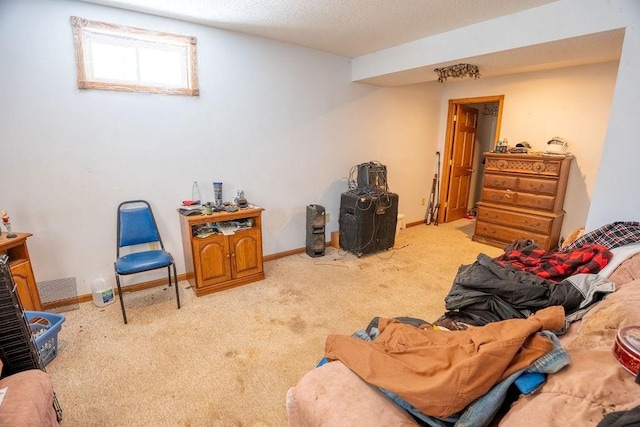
[286,254,640,427]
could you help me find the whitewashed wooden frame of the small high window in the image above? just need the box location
[71,16,200,96]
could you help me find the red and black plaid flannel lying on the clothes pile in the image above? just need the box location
[494,244,613,282]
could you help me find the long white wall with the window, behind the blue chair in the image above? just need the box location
[0,0,440,294]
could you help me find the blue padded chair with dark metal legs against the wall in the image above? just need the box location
[114,200,180,324]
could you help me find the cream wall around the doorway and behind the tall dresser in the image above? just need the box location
[438,62,618,236]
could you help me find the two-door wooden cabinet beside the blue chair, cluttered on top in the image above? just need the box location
[180,208,264,296]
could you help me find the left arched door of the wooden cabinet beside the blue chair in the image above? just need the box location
[194,236,231,287]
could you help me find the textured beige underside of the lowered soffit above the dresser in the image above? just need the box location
[358,29,624,86]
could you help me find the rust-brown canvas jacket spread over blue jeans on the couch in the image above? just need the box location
[325,306,564,418]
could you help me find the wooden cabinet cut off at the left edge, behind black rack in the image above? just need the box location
[0,233,42,311]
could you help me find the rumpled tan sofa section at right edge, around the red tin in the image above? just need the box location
[500,279,640,427]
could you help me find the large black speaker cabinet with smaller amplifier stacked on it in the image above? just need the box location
[340,191,398,256]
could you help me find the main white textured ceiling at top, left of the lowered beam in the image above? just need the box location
[81,0,556,58]
